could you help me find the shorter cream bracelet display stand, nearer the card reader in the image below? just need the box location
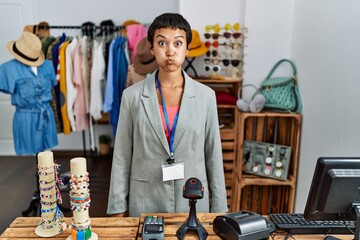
[67,157,98,240]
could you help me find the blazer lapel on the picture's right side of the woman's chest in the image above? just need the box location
[174,71,196,150]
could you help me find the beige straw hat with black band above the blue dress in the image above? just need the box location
[7,32,45,67]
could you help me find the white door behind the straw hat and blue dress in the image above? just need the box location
[0,0,38,155]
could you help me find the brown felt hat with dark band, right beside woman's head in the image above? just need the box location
[134,37,158,75]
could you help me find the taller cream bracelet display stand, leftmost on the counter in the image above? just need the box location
[35,151,66,237]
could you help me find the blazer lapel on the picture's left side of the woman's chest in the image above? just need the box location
[141,71,170,156]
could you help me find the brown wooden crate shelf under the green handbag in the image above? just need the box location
[231,112,301,215]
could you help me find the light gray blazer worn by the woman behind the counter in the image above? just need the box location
[107,69,227,216]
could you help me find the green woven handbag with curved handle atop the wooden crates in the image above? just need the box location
[260,59,302,113]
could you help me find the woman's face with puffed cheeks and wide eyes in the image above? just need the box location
[151,28,189,72]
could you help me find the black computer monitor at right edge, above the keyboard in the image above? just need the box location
[304,157,360,220]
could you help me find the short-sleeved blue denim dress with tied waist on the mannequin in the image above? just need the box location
[0,59,58,155]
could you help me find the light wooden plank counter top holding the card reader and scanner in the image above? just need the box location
[0,213,353,240]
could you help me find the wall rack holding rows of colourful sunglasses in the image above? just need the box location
[204,23,246,79]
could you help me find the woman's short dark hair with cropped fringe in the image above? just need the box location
[147,13,192,49]
